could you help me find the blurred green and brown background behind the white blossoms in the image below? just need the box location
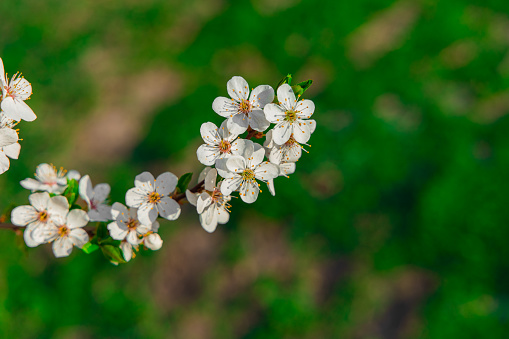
[0,0,509,339]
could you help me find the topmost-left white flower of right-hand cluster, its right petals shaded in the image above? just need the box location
[212,76,274,134]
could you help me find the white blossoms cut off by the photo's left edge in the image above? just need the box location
[0,58,37,174]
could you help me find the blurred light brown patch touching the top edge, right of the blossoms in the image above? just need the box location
[347,0,420,68]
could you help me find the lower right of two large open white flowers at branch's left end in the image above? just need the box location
[33,201,89,258]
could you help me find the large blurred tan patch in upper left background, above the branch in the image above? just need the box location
[73,50,183,166]
